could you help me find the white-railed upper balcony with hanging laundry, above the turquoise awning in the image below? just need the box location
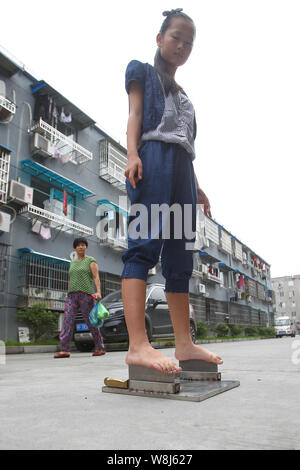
[31,118,93,165]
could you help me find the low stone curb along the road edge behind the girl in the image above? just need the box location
[5,337,274,354]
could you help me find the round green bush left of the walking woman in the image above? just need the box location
[16,302,58,341]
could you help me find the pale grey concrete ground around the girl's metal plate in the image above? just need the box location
[0,337,300,450]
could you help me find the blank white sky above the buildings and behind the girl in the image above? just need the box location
[0,0,300,277]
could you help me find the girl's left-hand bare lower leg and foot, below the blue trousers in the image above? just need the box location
[122,278,181,373]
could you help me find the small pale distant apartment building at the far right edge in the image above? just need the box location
[272,274,300,324]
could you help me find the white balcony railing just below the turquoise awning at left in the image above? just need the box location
[19,204,93,235]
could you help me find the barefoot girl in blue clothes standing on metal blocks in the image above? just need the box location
[122,9,223,373]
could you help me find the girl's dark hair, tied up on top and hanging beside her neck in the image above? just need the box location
[154,8,195,95]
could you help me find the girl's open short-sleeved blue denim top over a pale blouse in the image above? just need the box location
[125,60,197,139]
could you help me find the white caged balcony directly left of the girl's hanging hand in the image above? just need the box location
[99,139,127,192]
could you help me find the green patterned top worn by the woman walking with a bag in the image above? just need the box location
[68,256,96,294]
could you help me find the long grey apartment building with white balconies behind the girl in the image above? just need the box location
[0,51,273,340]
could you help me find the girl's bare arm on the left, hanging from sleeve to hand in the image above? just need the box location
[125,82,144,189]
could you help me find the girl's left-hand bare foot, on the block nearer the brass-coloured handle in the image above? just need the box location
[126,344,182,374]
